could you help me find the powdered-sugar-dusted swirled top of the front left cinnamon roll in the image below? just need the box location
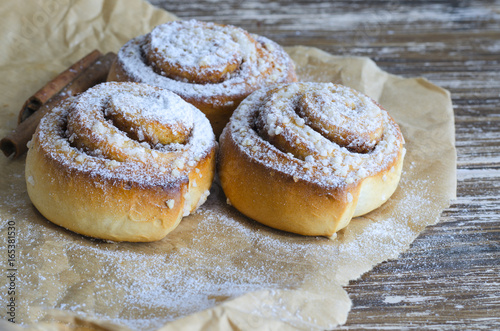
[32,83,215,186]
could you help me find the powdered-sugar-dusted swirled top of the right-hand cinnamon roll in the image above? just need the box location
[226,83,404,187]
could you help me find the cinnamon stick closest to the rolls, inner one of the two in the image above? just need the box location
[0,52,116,158]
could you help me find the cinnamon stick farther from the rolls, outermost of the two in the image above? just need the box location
[17,50,102,124]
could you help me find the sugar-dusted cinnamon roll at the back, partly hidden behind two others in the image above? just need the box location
[108,20,297,136]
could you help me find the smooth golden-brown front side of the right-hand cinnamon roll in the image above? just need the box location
[218,129,359,236]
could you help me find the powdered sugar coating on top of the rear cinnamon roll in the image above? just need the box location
[113,21,293,106]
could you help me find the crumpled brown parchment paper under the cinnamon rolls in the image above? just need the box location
[0,0,456,330]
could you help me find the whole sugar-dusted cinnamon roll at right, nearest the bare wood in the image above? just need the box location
[218,83,405,236]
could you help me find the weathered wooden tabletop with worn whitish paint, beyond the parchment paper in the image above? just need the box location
[151,0,500,330]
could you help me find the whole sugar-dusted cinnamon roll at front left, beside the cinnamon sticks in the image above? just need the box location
[26,82,217,242]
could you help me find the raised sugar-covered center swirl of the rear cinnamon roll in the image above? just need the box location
[143,21,252,83]
